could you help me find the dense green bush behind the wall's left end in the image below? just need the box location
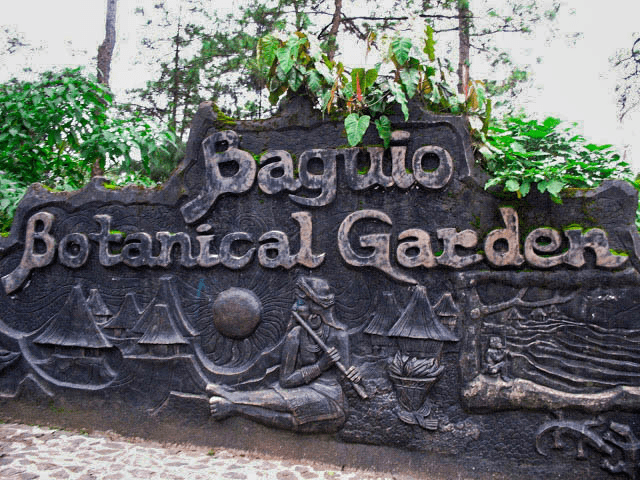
[0,68,177,231]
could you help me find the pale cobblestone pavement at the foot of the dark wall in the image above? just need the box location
[0,423,407,480]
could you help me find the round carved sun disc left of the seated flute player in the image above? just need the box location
[213,288,262,340]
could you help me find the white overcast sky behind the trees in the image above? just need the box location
[0,0,640,171]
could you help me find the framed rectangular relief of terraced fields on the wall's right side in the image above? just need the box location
[463,274,640,420]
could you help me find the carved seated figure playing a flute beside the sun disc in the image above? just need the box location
[207,277,360,432]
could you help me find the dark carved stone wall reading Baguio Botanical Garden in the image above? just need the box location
[0,96,640,478]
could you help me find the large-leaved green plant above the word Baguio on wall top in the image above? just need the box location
[258,27,490,146]
